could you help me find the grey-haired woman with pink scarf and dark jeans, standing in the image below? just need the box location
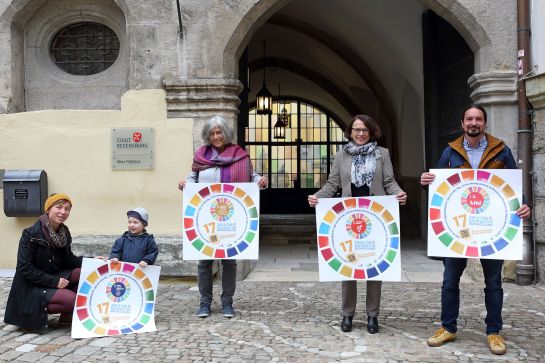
[178,116,268,318]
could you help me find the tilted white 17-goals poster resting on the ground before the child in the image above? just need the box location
[72,258,161,338]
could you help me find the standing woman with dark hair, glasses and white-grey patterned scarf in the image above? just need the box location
[308,115,407,334]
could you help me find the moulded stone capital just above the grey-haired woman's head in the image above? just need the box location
[163,79,242,149]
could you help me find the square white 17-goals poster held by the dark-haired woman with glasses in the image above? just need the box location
[316,196,401,281]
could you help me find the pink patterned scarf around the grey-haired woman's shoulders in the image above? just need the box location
[191,144,252,183]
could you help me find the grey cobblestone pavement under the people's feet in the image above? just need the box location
[0,278,545,362]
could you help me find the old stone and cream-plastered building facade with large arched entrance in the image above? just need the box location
[0,0,545,280]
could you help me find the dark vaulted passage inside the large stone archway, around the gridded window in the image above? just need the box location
[232,0,479,238]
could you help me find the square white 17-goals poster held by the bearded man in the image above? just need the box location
[428,169,522,260]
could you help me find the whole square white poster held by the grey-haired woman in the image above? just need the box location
[183,183,259,260]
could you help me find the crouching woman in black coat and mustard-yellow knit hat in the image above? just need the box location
[4,194,83,330]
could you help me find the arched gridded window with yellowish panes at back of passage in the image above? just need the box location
[244,99,344,214]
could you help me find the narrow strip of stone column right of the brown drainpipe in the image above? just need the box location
[526,73,545,284]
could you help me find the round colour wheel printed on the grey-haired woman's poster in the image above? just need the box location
[184,183,259,259]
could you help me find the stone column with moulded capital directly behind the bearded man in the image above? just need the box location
[468,70,518,281]
